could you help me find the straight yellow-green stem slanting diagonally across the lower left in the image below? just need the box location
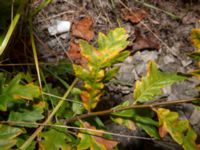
[19,78,78,150]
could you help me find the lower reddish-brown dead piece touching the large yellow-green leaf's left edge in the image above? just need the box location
[68,40,87,66]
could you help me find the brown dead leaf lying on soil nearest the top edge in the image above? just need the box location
[122,9,148,24]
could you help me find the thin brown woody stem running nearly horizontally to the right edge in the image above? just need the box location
[65,98,200,123]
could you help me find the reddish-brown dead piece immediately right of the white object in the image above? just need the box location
[72,16,94,41]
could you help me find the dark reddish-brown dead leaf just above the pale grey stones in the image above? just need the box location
[132,29,160,52]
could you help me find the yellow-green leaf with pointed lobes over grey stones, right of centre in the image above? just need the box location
[134,61,186,103]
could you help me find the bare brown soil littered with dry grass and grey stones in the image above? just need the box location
[33,0,200,150]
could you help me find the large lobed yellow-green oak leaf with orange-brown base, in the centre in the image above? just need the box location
[73,28,130,112]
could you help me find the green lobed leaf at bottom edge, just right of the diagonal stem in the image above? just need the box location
[39,128,72,150]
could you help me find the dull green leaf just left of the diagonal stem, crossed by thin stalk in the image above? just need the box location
[8,109,44,128]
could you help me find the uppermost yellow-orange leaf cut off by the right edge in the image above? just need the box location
[192,28,200,51]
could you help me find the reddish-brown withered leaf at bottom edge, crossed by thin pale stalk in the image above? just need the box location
[83,122,118,150]
